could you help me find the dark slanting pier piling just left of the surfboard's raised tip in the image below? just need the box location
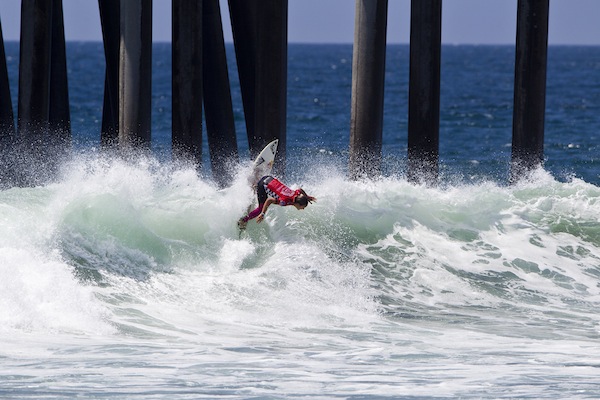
[202,0,239,187]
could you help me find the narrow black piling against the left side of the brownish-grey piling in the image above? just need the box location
[98,0,121,148]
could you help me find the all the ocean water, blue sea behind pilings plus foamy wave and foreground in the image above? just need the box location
[0,43,600,399]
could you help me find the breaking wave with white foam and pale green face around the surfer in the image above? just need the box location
[0,155,600,336]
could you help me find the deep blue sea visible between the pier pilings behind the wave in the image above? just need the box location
[6,42,600,185]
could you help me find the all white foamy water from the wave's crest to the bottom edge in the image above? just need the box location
[0,155,600,398]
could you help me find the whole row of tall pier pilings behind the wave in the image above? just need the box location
[0,0,549,185]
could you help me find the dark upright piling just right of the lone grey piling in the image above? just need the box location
[407,0,442,184]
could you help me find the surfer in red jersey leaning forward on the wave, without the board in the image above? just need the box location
[238,175,317,229]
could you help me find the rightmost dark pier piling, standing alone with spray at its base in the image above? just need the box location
[510,0,549,182]
